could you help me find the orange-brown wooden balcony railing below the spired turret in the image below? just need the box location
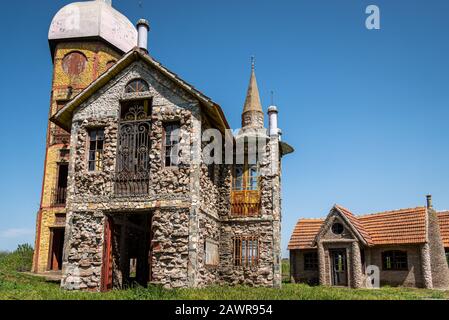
[231,191,261,217]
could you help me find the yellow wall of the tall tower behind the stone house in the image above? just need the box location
[33,42,121,273]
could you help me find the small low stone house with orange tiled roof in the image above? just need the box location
[288,196,449,289]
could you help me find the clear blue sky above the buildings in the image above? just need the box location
[0,0,449,255]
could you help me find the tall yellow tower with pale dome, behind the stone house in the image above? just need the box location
[33,0,137,273]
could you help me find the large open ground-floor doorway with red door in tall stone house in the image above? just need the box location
[101,213,152,291]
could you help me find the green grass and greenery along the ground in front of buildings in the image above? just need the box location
[0,246,449,300]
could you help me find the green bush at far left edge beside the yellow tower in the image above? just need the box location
[0,244,34,272]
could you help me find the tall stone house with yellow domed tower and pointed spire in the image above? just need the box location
[33,0,293,291]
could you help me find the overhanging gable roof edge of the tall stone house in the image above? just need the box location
[50,47,230,131]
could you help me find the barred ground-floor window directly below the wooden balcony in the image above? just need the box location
[233,237,259,267]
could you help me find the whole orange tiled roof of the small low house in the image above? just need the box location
[288,205,432,250]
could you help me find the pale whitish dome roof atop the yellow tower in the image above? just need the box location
[48,0,137,52]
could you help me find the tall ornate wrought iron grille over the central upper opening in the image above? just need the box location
[114,101,151,196]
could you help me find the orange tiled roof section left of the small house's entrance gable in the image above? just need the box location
[288,219,324,250]
